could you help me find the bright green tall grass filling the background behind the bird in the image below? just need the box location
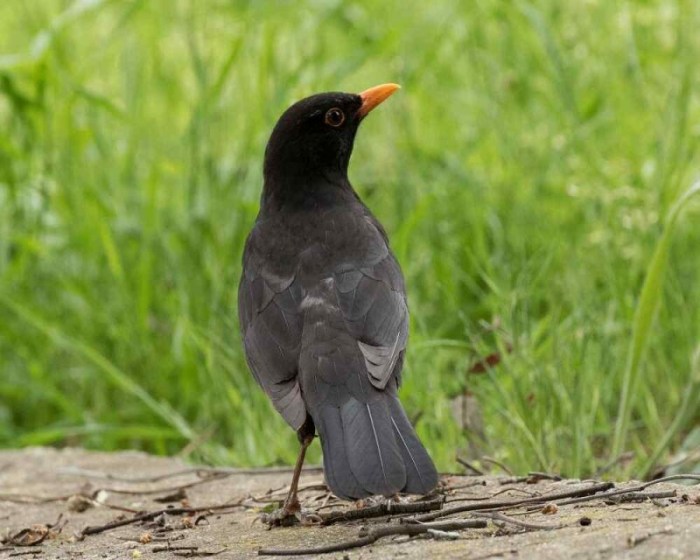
[0,0,700,476]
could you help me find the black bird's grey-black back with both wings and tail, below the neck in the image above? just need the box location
[239,198,437,498]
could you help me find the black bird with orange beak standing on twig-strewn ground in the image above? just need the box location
[238,83,438,518]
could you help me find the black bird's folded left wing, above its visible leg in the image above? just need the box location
[238,225,306,430]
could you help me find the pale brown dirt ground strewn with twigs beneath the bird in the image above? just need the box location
[0,448,700,560]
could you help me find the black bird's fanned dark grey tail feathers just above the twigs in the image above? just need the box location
[314,392,438,499]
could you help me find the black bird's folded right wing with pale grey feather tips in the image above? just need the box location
[334,214,408,389]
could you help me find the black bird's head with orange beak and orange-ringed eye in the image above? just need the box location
[264,84,399,197]
